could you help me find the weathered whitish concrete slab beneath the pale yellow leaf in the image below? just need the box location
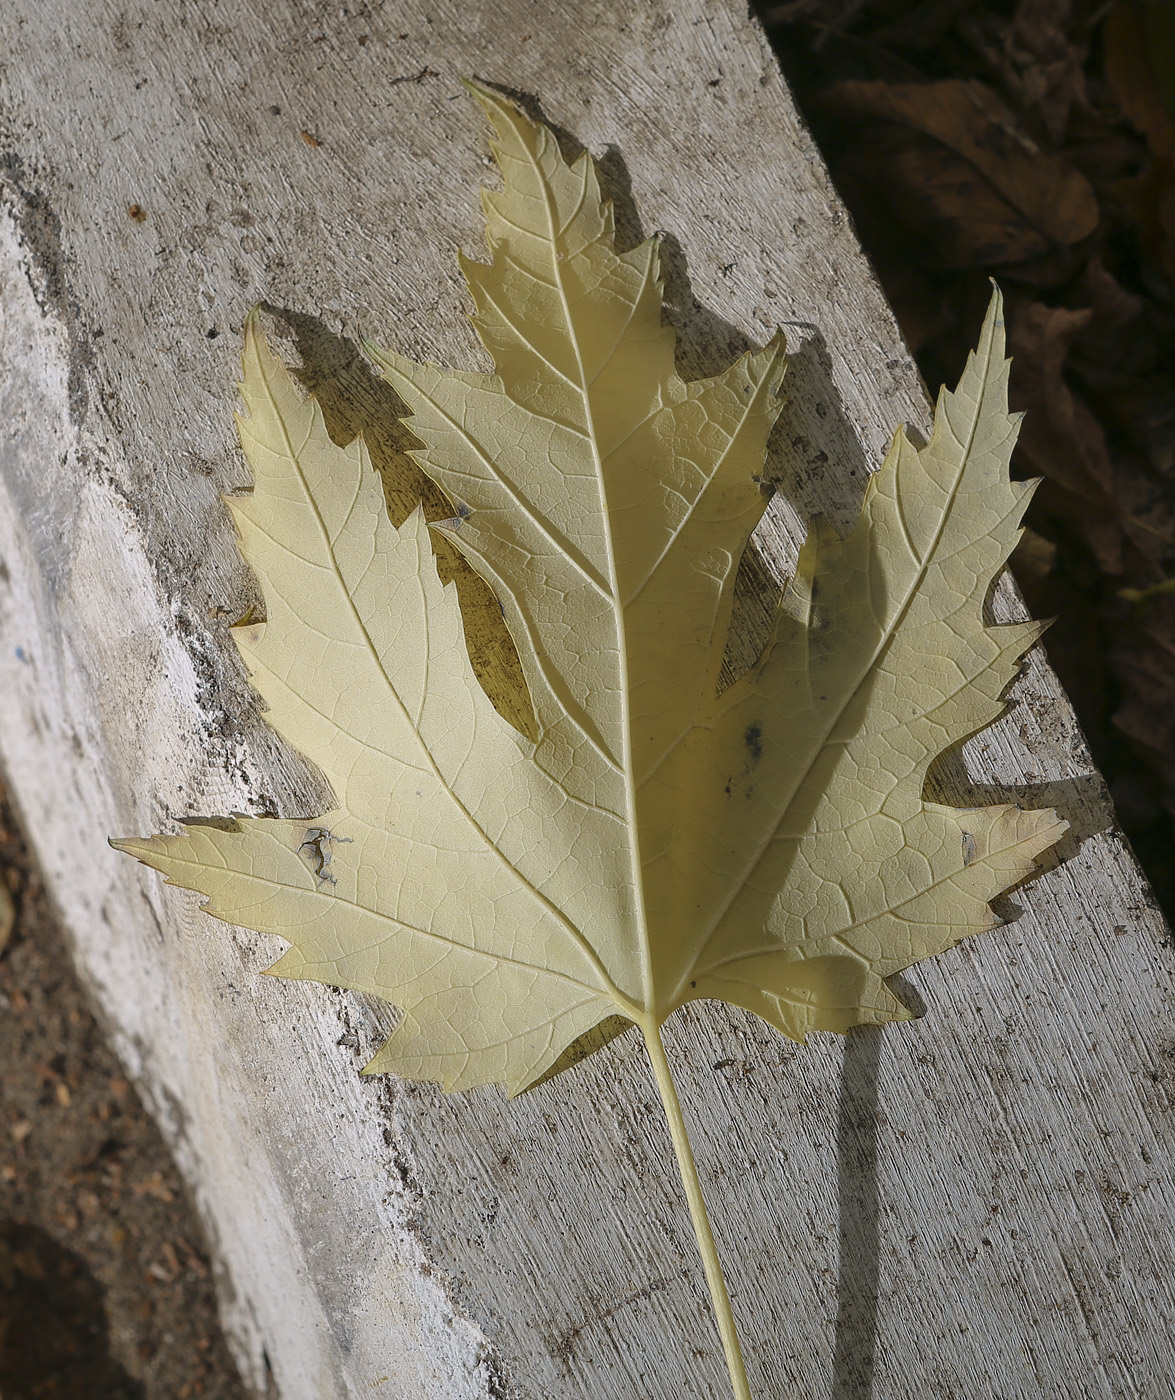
[0,0,1175,1400]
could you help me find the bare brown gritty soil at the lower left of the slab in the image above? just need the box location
[0,790,248,1400]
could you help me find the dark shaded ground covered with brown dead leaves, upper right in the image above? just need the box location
[758,0,1175,917]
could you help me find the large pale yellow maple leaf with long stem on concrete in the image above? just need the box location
[116,90,1066,1396]
